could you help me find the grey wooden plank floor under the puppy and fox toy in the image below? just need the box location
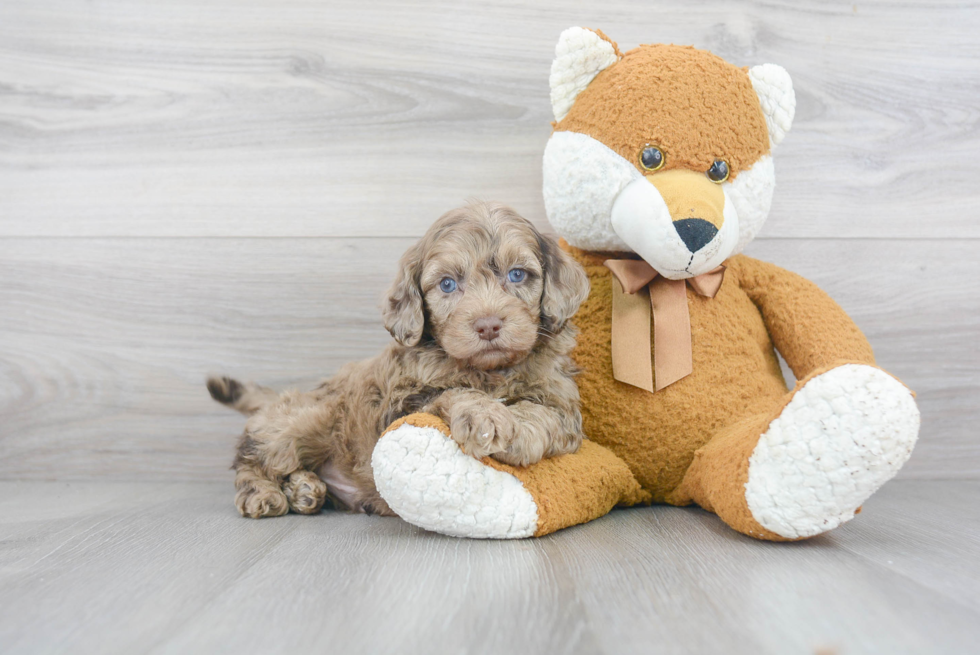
[0,480,980,655]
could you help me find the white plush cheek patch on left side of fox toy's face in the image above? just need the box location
[543,132,643,251]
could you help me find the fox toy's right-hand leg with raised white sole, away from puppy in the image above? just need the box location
[668,364,919,541]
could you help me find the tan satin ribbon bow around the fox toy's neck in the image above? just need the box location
[603,259,725,393]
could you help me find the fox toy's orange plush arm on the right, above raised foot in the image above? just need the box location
[732,256,875,380]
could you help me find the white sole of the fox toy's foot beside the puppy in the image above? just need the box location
[371,423,538,539]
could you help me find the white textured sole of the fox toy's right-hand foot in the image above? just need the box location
[745,364,919,539]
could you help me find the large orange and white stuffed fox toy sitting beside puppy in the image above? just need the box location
[373,28,919,541]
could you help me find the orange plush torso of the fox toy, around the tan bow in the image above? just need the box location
[562,243,786,502]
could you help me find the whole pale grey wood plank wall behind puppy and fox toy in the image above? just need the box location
[0,0,980,480]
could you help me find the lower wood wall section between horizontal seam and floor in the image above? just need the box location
[0,238,980,480]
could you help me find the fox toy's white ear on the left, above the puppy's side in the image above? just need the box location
[550,27,619,121]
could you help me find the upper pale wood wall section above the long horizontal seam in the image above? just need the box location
[0,0,980,239]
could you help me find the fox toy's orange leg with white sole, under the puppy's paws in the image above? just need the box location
[371,414,650,539]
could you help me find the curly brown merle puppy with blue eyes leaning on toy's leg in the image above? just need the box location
[208,203,589,518]
